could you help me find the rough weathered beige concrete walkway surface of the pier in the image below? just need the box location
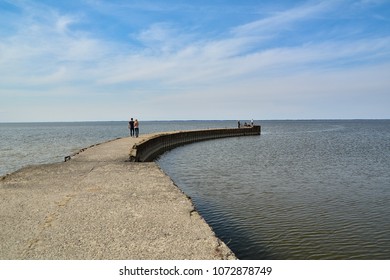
[0,136,235,259]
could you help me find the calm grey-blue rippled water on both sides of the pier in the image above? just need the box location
[0,120,390,259]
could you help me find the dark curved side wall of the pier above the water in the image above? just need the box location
[129,125,261,162]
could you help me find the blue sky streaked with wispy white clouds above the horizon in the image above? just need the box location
[0,0,390,122]
